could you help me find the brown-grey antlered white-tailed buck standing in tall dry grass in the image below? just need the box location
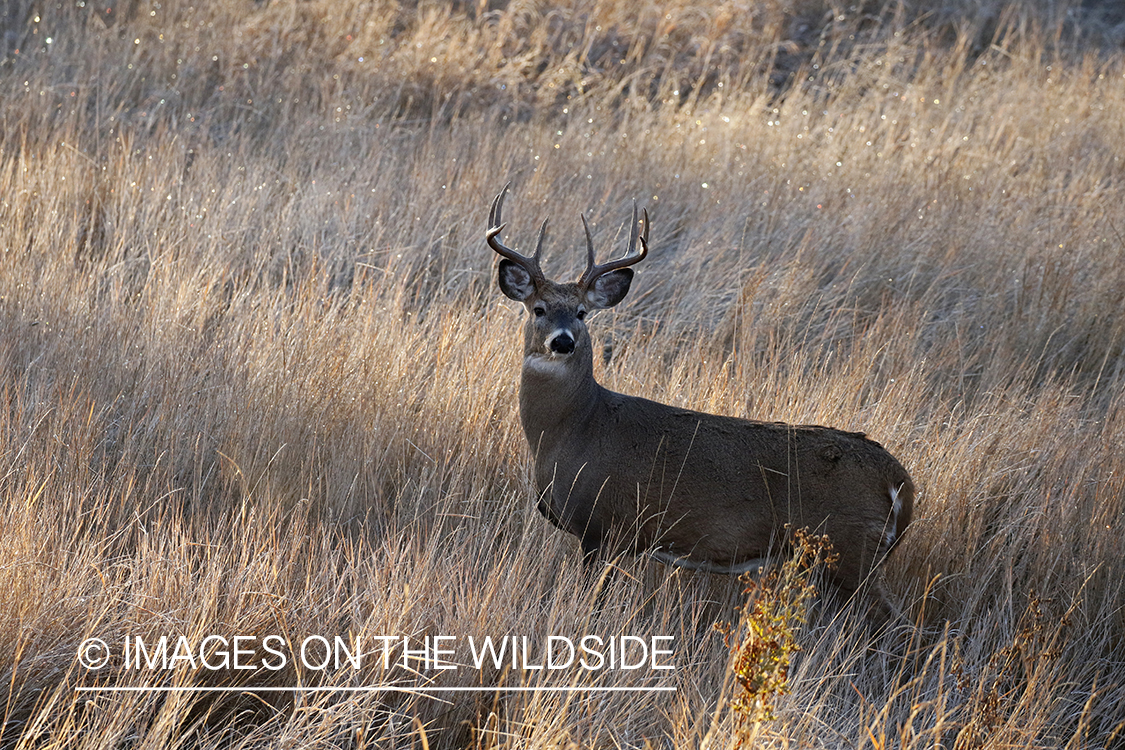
[485,186,915,611]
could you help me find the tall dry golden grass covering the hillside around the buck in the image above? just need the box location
[0,0,1125,749]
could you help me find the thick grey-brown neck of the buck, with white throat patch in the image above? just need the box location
[520,346,604,452]
